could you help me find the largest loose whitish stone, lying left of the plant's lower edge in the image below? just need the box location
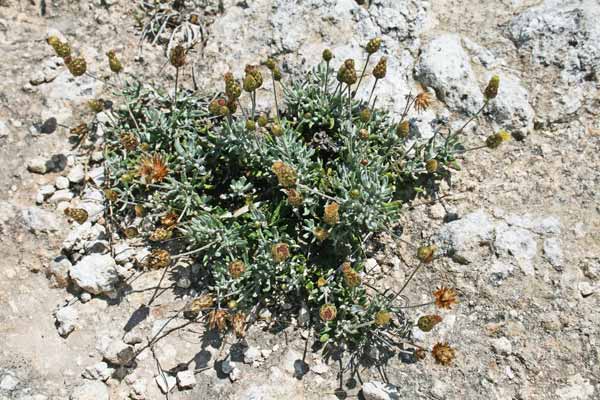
[69,254,119,294]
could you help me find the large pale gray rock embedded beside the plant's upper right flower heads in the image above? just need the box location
[416,34,483,114]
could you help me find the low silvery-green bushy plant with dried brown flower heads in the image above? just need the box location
[50,34,509,378]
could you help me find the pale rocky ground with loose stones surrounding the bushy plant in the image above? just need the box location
[0,0,600,400]
